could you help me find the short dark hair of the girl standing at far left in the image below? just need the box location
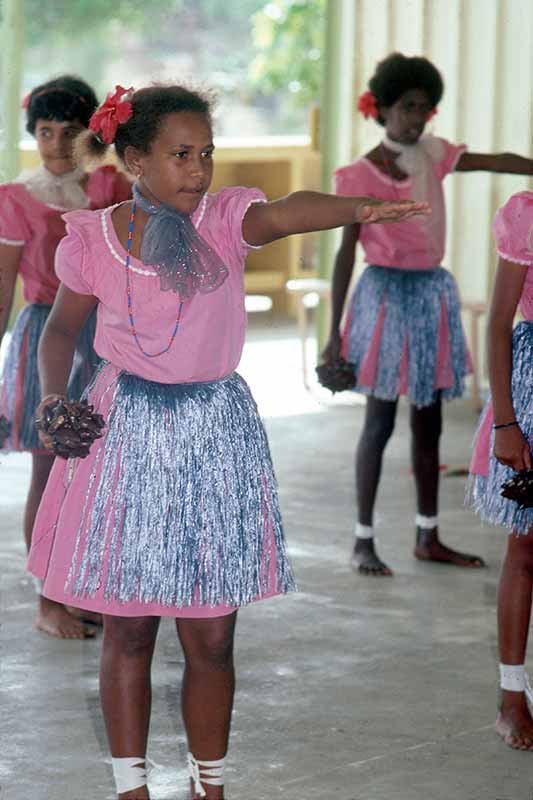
[26,75,98,135]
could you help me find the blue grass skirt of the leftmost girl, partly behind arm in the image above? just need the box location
[0,303,99,452]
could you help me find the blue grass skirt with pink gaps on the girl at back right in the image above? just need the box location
[343,266,471,408]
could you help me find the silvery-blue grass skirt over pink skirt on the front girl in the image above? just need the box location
[29,364,295,616]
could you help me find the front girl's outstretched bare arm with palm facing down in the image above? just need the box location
[242,192,430,245]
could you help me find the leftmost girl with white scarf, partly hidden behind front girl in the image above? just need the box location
[0,75,131,638]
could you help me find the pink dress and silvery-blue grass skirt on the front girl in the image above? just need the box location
[29,187,293,617]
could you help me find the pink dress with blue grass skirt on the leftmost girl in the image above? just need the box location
[0,166,131,453]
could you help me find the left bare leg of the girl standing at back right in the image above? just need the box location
[352,397,398,576]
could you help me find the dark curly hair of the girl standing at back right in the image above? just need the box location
[368,53,444,125]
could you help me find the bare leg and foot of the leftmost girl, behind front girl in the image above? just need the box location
[24,453,94,639]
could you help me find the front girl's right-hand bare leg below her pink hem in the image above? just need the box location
[176,612,237,800]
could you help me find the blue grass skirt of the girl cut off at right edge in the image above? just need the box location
[466,322,533,534]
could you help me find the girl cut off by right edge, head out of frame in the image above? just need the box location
[467,192,533,750]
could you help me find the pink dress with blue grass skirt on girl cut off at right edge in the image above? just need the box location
[467,192,533,534]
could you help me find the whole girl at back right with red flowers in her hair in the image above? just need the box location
[323,53,533,576]
